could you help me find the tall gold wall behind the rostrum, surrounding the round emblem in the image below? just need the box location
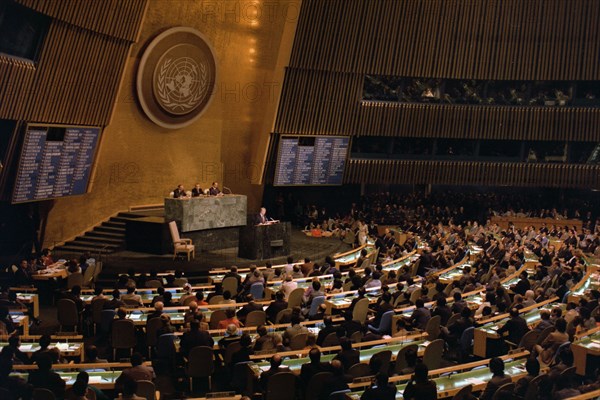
[46,0,300,244]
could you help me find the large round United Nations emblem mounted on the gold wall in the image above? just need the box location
[137,27,216,129]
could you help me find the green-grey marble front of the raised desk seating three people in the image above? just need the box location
[165,194,248,232]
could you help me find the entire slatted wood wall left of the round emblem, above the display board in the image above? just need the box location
[0,0,147,126]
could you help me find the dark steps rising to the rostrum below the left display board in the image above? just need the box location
[53,210,162,258]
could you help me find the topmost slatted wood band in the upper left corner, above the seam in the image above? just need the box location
[14,0,147,42]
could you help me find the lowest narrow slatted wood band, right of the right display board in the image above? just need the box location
[344,159,600,189]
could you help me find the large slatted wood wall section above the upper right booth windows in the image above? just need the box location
[290,0,600,80]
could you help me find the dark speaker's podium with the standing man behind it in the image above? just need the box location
[238,221,292,260]
